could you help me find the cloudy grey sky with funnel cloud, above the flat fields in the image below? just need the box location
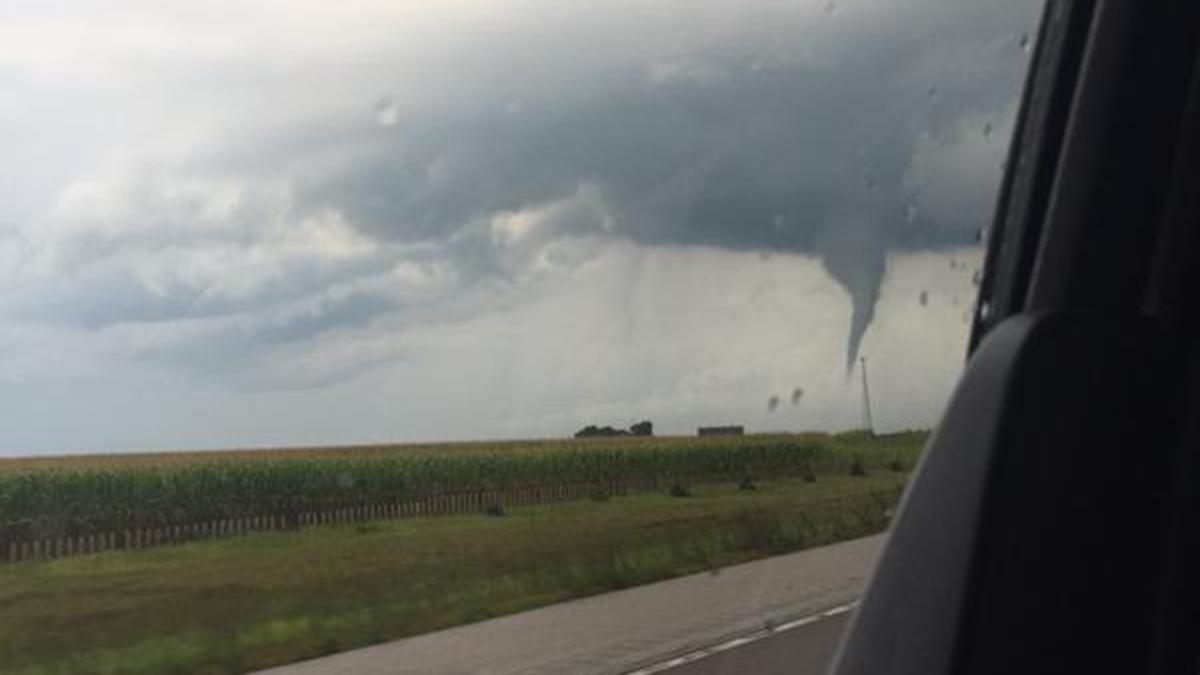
[0,0,1040,454]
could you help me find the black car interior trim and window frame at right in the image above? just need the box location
[833,0,1200,675]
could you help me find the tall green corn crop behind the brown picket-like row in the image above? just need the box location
[0,432,924,543]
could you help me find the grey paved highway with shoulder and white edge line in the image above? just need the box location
[250,536,884,675]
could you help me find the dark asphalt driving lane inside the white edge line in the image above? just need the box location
[658,614,850,675]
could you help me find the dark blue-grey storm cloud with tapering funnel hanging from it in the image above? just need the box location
[280,2,1032,364]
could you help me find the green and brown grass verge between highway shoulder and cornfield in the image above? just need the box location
[0,468,905,675]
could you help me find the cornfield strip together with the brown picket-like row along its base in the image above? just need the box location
[0,434,924,560]
